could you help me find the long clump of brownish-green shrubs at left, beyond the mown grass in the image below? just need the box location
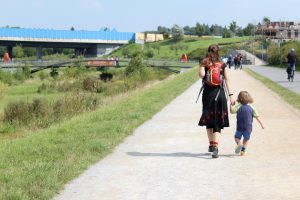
[0,93,99,132]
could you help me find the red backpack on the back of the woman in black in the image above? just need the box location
[204,62,224,86]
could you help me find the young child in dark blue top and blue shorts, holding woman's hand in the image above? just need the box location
[230,91,264,156]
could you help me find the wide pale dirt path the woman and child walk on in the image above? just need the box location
[55,70,300,200]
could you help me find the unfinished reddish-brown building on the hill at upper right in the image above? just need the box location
[255,21,300,41]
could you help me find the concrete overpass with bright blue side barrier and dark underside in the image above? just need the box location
[0,28,135,59]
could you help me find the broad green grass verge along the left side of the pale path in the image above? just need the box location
[0,68,198,199]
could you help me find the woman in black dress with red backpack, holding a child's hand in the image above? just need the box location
[198,45,234,158]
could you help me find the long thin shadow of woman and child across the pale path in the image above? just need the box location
[127,152,238,159]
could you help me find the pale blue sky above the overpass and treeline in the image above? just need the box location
[0,0,300,32]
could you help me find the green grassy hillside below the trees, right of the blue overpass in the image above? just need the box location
[112,37,250,60]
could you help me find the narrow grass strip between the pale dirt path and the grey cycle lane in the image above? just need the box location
[246,69,300,110]
